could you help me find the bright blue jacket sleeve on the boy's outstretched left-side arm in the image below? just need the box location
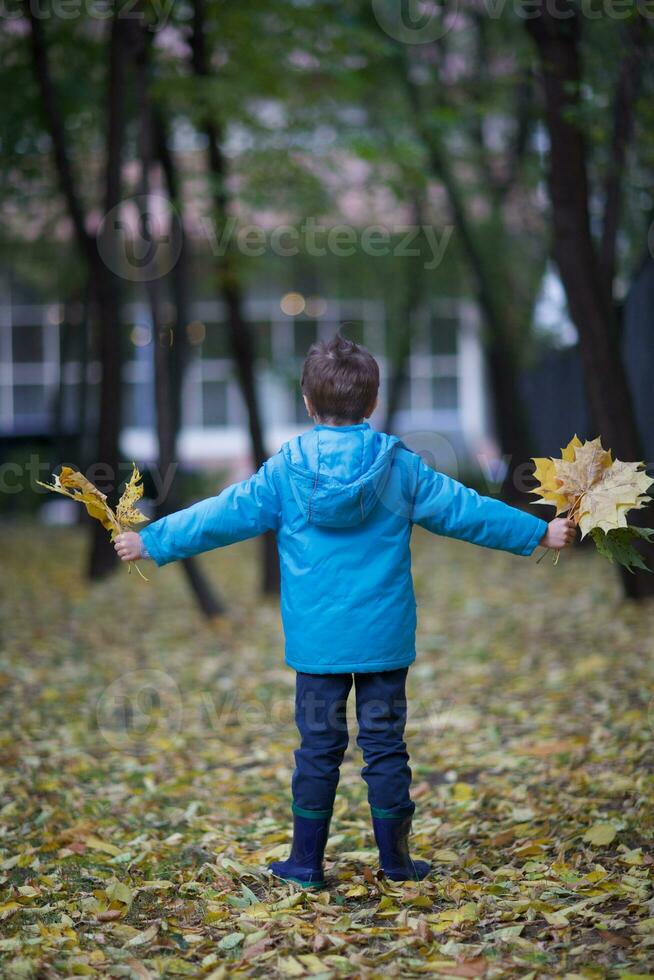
[140,459,280,565]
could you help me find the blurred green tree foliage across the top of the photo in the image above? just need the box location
[0,0,654,334]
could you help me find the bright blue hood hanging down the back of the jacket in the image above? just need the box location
[281,422,401,527]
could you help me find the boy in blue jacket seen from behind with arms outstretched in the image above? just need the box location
[115,335,575,888]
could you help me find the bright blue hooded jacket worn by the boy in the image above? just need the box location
[141,423,547,674]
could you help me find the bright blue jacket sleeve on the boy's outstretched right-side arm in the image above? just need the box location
[413,459,547,555]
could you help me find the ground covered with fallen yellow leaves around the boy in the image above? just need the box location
[0,526,654,980]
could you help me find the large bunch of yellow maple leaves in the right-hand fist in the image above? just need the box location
[533,436,654,572]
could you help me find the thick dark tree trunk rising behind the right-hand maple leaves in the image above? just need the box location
[526,7,654,598]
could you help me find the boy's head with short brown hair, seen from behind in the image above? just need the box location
[300,334,379,425]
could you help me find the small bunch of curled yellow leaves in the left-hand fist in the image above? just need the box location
[36,463,147,581]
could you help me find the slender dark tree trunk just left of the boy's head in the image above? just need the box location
[191,0,279,594]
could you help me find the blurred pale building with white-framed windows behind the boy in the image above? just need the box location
[0,274,492,465]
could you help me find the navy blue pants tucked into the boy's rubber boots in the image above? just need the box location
[293,667,414,816]
